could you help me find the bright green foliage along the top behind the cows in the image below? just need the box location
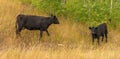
[22,0,120,26]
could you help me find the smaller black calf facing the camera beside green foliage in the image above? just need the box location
[89,23,108,45]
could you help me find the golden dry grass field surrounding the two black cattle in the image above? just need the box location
[0,0,120,59]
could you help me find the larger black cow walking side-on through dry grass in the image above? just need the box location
[16,14,59,38]
